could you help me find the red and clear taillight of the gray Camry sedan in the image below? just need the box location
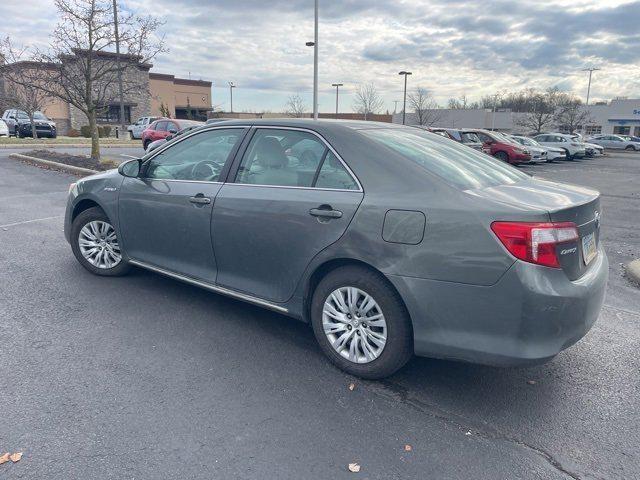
[491,222,579,268]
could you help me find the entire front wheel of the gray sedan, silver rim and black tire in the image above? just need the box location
[71,207,131,277]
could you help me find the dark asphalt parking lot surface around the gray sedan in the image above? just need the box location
[0,151,640,480]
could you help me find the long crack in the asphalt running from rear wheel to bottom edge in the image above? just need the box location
[366,380,581,480]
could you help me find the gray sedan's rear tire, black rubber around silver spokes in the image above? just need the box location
[311,266,413,380]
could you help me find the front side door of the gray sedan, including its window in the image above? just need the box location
[118,127,246,283]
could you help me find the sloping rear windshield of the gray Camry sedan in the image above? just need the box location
[360,128,529,190]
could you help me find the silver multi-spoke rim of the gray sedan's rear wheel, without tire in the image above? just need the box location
[322,286,387,363]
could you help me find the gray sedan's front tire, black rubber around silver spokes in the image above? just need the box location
[71,207,131,277]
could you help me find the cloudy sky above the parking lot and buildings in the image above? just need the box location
[0,0,640,111]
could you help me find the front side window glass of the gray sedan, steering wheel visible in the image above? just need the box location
[145,128,243,182]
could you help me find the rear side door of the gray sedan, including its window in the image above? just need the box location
[213,127,363,302]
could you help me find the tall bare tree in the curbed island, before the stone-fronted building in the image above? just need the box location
[16,0,165,159]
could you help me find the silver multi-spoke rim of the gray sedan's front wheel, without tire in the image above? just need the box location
[78,220,122,269]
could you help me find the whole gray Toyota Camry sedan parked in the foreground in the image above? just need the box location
[64,119,608,378]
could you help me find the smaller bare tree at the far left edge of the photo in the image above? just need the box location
[0,37,51,138]
